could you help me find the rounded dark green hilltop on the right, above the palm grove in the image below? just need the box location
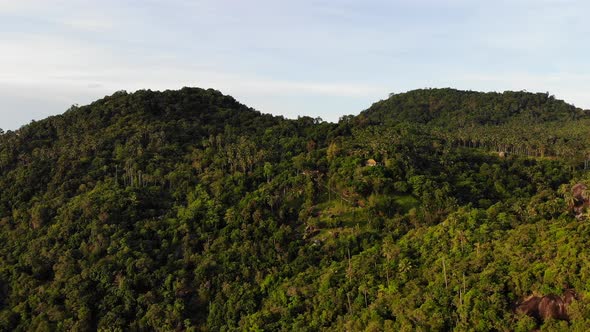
[361,88,590,129]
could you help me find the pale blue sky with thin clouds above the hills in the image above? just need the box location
[0,0,590,130]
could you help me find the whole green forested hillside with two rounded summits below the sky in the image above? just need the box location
[0,88,590,331]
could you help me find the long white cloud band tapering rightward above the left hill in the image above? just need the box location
[0,32,383,96]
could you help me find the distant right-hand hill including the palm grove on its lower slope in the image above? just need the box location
[357,89,590,163]
